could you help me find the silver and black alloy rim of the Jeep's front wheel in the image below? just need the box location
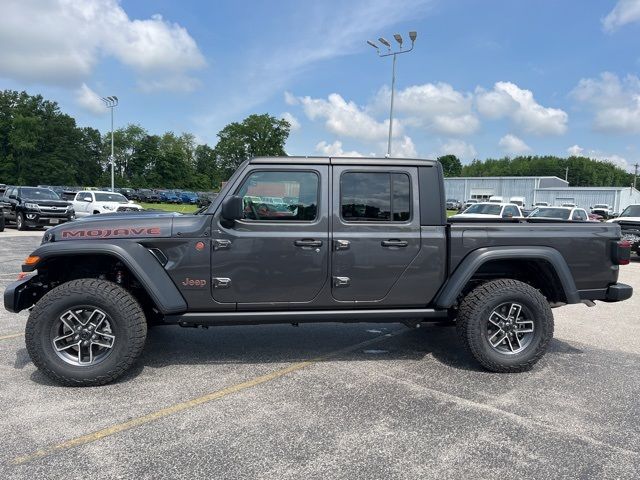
[51,307,116,367]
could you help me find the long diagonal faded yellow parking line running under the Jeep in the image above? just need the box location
[11,329,404,465]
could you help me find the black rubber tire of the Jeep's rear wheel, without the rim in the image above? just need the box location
[456,279,553,373]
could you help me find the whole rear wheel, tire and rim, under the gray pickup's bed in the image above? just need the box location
[456,279,553,372]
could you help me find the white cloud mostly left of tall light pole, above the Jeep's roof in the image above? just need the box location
[299,93,402,141]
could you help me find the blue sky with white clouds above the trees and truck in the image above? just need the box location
[0,0,640,168]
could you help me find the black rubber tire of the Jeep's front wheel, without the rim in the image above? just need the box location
[25,278,147,386]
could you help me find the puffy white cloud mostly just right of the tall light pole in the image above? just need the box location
[375,82,480,135]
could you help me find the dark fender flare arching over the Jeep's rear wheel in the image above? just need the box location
[434,247,580,308]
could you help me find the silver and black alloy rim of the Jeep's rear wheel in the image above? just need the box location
[487,302,535,355]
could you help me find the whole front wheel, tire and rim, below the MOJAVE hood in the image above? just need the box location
[25,279,147,386]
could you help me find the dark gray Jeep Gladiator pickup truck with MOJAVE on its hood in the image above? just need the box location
[4,157,632,385]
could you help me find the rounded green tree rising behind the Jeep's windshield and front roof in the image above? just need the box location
[214,113,291,180]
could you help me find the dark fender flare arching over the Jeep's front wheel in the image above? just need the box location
[22,240,187,315]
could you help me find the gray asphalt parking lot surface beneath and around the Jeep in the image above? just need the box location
[0,230,640,479]
